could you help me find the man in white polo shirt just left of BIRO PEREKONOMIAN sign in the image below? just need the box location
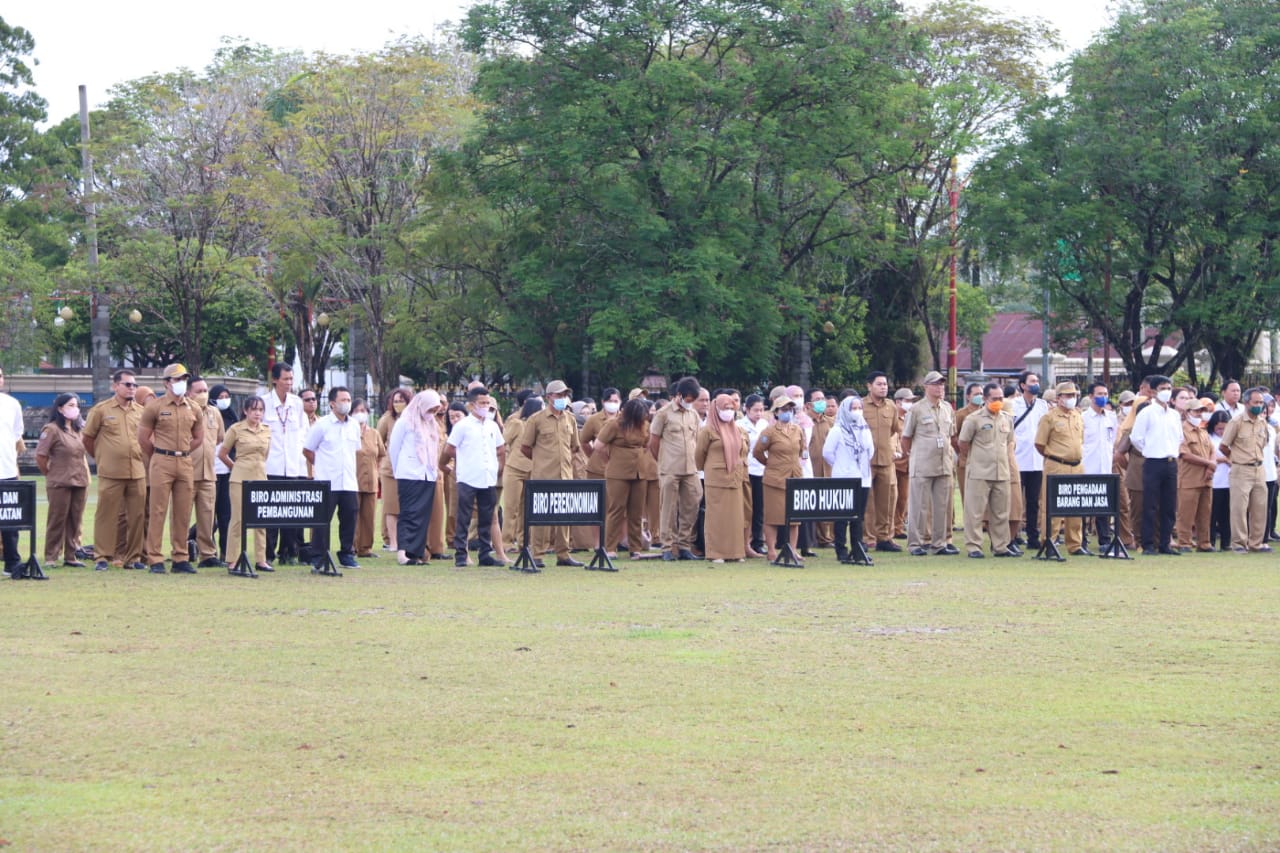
[442,386,507,566]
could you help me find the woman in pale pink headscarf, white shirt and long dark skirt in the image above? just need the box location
[387,388,440,566]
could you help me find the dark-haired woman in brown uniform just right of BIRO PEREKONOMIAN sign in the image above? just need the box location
[591,400,658,560]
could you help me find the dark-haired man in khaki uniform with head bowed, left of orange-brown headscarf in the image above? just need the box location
[649,377,703,560]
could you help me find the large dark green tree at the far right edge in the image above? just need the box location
[970,0,1280,382]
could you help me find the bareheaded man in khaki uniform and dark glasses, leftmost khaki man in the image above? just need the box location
[83,370,147,571]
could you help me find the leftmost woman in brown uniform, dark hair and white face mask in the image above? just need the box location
[36,394,90,569]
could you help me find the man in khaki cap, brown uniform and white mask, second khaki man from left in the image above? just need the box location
[138,364,205,575]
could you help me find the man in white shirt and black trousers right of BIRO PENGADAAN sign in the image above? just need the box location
[1129,375,1190,556]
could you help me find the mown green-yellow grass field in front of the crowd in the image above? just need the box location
[0,481,1280,850]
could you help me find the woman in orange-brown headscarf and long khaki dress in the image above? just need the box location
[694,394,747,562]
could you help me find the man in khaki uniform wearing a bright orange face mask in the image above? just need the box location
[956,382,1018,558]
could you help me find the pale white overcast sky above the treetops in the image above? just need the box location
[15,0,1110,122]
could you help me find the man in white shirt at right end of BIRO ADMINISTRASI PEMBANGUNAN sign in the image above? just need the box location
[300,386,360,569]
